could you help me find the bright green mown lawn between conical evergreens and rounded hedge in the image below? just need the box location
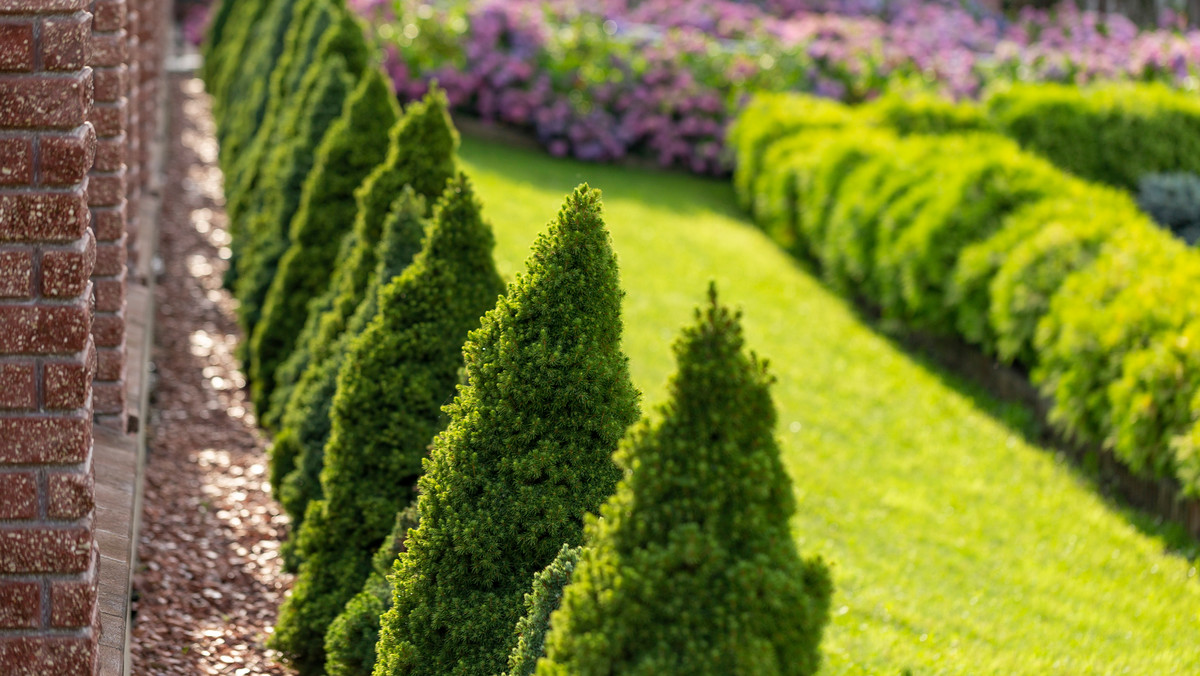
[462,139,1200,675]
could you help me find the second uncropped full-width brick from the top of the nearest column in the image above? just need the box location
[0,186,90,241]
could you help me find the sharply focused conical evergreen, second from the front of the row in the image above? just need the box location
[374,186,638,676]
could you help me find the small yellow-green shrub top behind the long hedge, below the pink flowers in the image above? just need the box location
[860,92,990,134]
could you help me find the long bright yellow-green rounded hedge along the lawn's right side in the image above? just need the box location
[731,96,1200,493]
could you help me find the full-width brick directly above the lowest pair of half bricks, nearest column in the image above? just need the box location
[0,526,94,574]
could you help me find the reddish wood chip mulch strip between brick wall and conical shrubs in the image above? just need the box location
[132,74,292,676]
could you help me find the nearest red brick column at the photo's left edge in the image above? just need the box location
[0,0,104,676]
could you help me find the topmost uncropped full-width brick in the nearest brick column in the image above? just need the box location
[0,68,92,128]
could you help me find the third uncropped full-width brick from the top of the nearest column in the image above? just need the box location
[0,298,91,354]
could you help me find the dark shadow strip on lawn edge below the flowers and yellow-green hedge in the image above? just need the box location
[462,130,1200,562]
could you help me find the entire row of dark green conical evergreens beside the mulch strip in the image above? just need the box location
[205,5,829,676]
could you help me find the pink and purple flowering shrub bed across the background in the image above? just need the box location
[350,0,1200,173]
